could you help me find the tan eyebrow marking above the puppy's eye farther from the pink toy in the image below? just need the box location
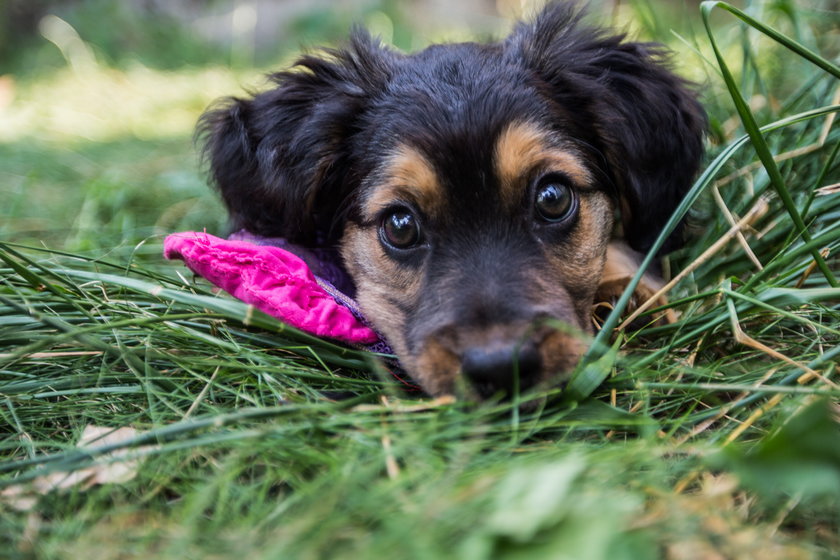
[495,122,592,208]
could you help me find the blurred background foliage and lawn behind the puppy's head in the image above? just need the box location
[0,0,839,251]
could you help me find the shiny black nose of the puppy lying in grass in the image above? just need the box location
[461,344,542,398]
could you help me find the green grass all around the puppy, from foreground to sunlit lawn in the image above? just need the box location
[0,0,840,560]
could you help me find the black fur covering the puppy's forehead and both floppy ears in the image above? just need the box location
[200,3,705,251]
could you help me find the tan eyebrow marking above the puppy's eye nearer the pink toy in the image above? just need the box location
[362,145,444,219]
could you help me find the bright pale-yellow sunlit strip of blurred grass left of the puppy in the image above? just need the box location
[0,64,260,144]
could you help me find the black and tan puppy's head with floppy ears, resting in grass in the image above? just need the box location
[202,3,705,396]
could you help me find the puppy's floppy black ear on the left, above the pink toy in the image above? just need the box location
[198,29,397,243]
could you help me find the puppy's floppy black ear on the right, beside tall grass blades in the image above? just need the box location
[505,2,706,251]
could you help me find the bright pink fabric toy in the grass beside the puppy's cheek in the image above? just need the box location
[163,232,380,351]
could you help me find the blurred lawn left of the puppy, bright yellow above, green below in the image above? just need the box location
[0,60,262,250]
